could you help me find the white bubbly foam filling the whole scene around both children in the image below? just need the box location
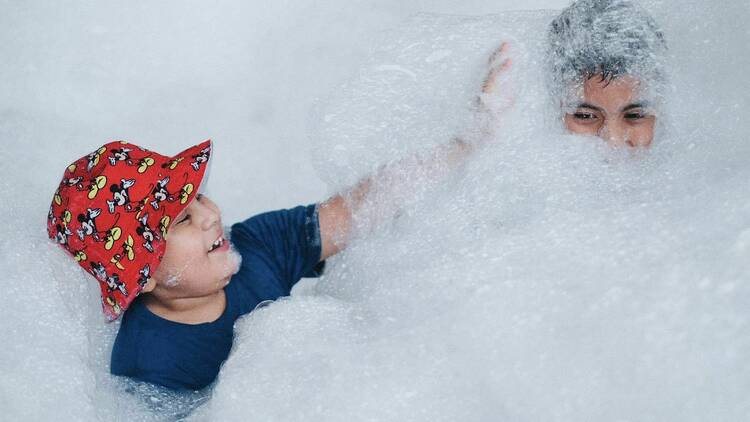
[0,1,750,421]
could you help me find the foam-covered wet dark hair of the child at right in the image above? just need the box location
[546,0,667,103]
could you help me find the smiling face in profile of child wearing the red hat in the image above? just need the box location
[154,195,239,298]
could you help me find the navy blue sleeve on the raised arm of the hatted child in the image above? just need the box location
[231,204,324,294]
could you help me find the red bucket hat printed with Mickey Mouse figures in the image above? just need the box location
[47,140,211,321]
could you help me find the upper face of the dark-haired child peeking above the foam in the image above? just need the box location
[564,75,656,147]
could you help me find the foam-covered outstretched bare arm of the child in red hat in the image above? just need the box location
[319,43,513,260]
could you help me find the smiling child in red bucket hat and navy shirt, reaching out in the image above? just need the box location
[47,46,510,390]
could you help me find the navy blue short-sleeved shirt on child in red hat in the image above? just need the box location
[111,205,323,390]
